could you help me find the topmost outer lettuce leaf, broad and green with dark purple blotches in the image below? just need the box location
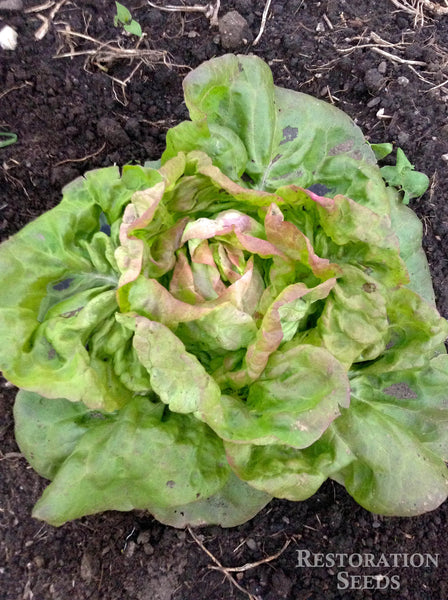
[163,55,389,214]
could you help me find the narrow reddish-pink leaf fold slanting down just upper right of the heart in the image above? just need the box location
[265,204,340,279]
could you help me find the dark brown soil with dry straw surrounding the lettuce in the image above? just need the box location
[0,0,448,600]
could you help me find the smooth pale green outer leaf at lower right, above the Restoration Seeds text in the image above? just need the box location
[332,366,448,516]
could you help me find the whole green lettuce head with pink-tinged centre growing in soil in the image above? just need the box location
[0,55,448,527]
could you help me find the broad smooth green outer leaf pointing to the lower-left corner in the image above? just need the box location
[28,397,229,525]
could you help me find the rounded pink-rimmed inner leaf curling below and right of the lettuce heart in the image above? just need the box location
[199,345,349,448]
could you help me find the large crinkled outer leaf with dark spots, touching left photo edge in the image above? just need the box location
[0,167,160,410]
